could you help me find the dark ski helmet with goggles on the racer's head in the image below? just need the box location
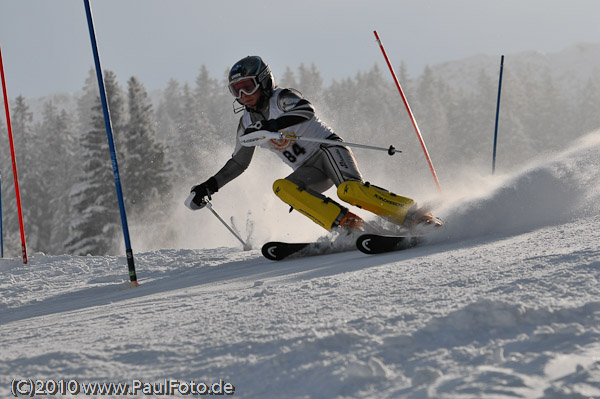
[229,55,274,100]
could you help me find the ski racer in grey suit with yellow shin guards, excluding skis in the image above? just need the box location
[185,56,439,232]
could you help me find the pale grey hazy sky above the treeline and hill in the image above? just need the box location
[0,0,600,98]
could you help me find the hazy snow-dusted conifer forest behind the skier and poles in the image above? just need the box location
[0,59,600,257]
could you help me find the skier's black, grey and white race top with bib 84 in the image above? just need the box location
[215,88,341,188]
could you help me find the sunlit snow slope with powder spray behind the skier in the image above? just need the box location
[0,133,600,399]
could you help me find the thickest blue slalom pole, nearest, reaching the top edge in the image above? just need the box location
[83,0,138,286]
